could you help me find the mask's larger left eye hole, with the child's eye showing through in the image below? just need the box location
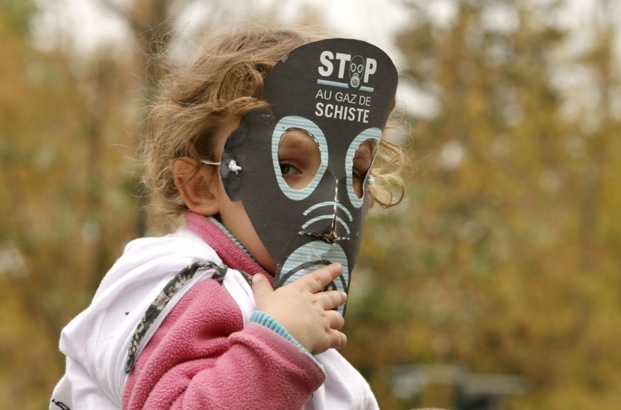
[278,128,321,190]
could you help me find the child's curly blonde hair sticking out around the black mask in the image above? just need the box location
[141,26,405,231]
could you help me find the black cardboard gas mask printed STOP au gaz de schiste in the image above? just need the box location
[220,39,397,314]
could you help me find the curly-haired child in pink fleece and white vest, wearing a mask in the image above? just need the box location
[50,27,403,409]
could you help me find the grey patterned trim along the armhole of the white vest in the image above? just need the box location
[125,261,228,373]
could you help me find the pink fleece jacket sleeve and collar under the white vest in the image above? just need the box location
[123,214,325,409]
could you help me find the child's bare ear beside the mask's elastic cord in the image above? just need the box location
[173,157,220,216]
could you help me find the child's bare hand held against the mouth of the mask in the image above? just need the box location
[252,263,347,354]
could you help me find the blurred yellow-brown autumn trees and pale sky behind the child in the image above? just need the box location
[0,0,621,410]
